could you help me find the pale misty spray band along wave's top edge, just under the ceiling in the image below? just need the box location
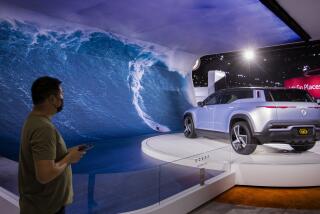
[0,3,199,72]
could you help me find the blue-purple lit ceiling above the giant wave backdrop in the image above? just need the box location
[0,0,320,56]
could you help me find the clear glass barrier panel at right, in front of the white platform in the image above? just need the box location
[159,146,230,203]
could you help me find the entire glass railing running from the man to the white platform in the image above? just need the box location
[67,146,232,213]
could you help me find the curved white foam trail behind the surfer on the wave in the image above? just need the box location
[127,54,170,132]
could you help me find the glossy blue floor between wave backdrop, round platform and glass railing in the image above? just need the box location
[73,134,164,174]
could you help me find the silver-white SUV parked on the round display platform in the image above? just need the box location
[184,88,320,155]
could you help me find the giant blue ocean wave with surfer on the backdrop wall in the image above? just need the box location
[0,19,190,160]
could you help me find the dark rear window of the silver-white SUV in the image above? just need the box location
[265,89,314,102]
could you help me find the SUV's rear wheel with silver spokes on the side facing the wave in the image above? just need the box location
[230,121,257,155]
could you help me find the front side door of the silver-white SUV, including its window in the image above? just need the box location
[197,94,218,130]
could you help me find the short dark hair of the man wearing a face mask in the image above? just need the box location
[31,76,61,105]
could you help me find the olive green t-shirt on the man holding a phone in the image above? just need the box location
[19,114,73,214]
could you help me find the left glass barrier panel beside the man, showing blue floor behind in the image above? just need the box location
[69,167,159,213]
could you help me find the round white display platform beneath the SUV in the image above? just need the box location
[142,134,320,187]
